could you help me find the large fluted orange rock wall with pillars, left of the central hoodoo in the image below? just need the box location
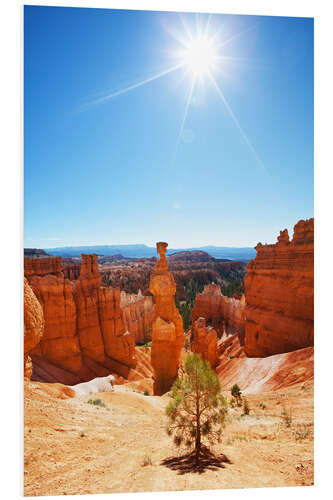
[25,255,136,383]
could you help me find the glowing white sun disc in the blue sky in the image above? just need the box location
[180,37,218,76]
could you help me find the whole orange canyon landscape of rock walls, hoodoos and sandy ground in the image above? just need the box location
[24,219,314,495]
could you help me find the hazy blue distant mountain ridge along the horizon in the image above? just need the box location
[45,244,256,264]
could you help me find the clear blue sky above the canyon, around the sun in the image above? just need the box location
[24,7,313,248]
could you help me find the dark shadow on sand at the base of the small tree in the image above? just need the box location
[161,446,232,474]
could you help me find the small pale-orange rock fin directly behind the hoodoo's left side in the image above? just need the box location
[120,290,155,344]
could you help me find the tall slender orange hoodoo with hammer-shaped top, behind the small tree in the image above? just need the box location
[149,242,184,395]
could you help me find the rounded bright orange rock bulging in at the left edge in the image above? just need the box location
[24,278,44,379]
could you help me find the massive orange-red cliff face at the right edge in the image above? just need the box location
[245,219,314,357]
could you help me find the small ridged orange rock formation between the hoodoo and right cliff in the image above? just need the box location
[192,283,245,337]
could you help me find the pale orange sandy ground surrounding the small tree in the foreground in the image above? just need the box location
[24,381,313,496]
